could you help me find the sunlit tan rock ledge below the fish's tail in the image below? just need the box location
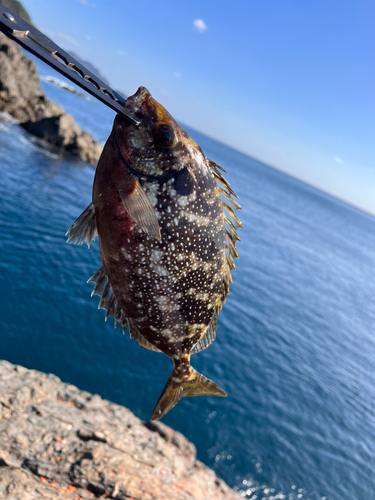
[0,361,240,500]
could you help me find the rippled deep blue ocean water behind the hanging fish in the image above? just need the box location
[0,60,375,500]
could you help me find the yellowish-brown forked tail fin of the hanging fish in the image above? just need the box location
[151,366,226,420]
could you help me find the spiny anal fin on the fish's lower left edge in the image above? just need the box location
[87,266,161,352]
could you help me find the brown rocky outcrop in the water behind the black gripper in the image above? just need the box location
[0,33,102,164]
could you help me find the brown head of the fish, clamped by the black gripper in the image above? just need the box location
[113,87,204,177]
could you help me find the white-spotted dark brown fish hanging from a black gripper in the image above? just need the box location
[67,87,242,420]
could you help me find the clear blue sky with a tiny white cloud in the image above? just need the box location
[23,0,375,214]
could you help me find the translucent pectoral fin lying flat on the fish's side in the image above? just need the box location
[119,177,161,241]
